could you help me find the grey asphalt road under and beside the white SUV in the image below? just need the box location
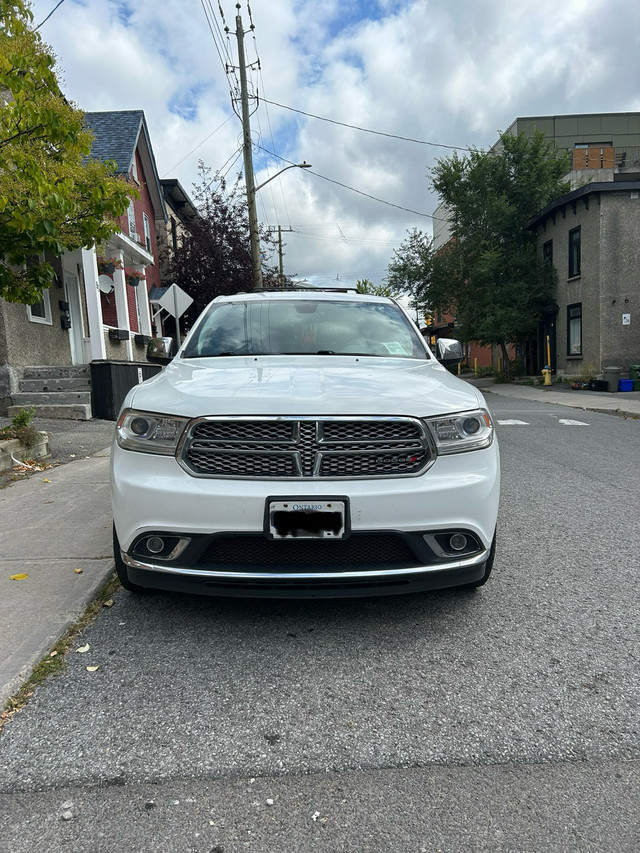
[0,395,640,853]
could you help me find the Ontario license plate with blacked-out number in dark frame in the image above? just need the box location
[267,500,345,539]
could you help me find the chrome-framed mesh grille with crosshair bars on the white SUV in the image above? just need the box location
[178,417,433,479]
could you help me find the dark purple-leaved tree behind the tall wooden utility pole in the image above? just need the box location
[168,162,280,329]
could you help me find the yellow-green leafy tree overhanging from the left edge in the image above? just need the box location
[0,0,137,304]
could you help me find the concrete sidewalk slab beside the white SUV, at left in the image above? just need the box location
[0,448,114,708]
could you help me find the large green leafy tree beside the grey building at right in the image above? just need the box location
[427,133,569,371]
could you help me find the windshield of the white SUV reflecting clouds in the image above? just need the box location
[182,299,429,359]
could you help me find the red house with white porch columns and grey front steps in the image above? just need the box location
[0,110,166,419]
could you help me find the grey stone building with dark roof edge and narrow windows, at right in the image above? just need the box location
[528,180,640,376]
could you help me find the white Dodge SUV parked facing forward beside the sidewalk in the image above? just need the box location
[111,291,500,597]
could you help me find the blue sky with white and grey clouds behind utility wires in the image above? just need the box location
[27,0,640,286]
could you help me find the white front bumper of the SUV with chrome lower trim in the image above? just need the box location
[111,442,499,597]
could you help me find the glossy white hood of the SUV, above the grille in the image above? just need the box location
[124,356,485,417]
